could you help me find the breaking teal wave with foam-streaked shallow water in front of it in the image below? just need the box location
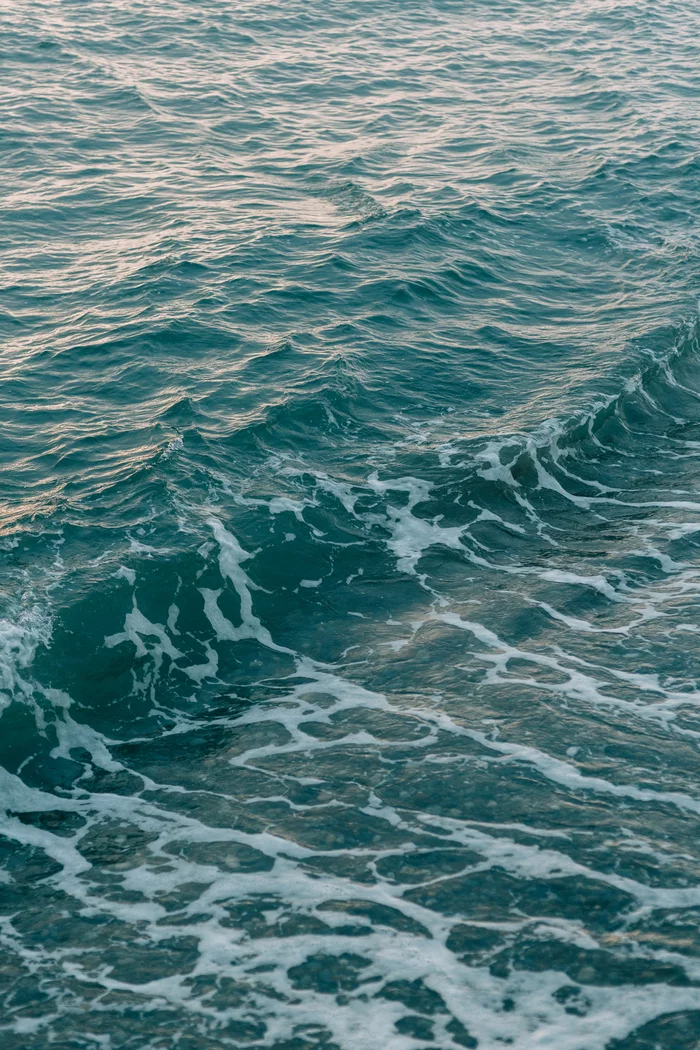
[0,324,700,1047]
